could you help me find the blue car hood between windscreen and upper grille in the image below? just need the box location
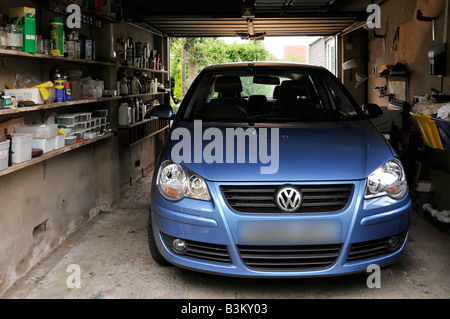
[163,120,395,182]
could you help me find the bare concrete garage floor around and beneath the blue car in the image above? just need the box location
[2,174,450,299]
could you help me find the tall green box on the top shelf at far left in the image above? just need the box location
[8,7,36,53]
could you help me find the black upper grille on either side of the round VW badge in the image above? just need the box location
[221,184,353,214]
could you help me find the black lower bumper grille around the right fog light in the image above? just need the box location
[347,233,407,262]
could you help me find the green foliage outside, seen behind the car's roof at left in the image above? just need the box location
[170,38,278,101]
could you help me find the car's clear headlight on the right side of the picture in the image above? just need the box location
[364,158,408,199]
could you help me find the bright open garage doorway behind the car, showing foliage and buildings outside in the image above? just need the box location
[170,36,337,105]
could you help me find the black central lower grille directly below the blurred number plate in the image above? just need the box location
[237,244,342,271]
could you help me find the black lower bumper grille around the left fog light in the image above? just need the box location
[161,233,231,264]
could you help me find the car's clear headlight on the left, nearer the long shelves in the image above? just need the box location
[156,160,211,201]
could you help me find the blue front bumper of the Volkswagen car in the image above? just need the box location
[151,181,411,277]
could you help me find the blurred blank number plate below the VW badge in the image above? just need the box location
[238,220,341,245]
